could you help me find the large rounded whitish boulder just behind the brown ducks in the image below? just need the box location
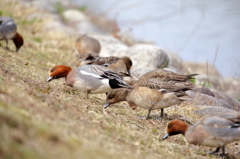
[127,44,169,70]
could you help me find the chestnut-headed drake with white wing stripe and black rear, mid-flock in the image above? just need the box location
[47,65,132,98]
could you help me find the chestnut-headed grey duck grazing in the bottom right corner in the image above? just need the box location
[162,113,240,156]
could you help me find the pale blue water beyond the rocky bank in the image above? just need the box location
[72,0,240,77]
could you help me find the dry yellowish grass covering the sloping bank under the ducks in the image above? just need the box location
[0,0,238,159]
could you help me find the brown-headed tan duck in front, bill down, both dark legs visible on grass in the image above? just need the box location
[103,83,191,119]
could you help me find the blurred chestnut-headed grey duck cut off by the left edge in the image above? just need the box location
[0,17,24,52]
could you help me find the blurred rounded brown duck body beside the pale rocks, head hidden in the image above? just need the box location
[75,35,101,54]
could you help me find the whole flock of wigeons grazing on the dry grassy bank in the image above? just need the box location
[0,17,240,156]
